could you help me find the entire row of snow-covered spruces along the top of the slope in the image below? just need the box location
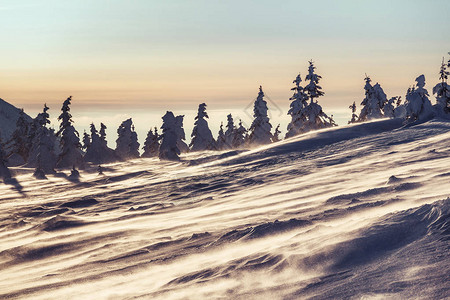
[0,59,450,172]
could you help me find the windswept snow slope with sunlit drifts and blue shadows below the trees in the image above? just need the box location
[0,119,450,299]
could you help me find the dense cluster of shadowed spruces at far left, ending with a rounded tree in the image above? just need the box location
[0,96,140,178]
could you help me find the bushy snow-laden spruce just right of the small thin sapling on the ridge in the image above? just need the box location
[358,76,387,122]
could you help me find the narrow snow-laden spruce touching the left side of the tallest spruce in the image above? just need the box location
[286,74,308,138]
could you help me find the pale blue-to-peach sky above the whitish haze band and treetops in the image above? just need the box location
[0,0,450,141]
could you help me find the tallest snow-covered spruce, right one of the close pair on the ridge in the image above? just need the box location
[302,61,337,132]
